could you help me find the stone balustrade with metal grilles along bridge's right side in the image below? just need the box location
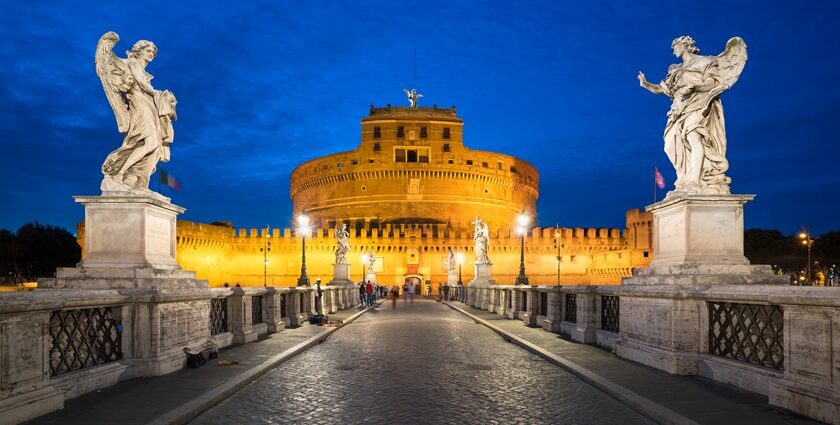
[459,285,840,424]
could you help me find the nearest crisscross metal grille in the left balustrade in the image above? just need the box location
[49,307,123,376]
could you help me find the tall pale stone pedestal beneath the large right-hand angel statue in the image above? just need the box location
[616,195,787,374]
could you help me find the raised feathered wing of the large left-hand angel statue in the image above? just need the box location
[95,31,134,133]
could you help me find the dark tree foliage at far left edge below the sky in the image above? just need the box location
[0,223,82,283]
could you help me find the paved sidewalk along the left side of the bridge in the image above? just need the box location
[25,307,374,425]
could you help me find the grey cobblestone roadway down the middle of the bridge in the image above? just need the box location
[192,300,652,424]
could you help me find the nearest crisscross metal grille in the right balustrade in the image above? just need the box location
[707,302,785,370]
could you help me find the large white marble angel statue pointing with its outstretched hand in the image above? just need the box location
[638,35,747,195]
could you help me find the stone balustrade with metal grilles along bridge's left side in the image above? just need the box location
[0,286,358,423]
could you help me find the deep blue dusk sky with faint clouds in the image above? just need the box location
[0,1,840,235]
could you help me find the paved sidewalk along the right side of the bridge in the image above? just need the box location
[446,302,818,425]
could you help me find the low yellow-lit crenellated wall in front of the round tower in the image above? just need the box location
[143,205,653,288]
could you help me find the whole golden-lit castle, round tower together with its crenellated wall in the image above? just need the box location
[78,101,653,289]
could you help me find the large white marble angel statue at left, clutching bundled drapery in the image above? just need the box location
[96,31,176,192]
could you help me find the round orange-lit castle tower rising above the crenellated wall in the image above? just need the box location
[290,105,539,228]
